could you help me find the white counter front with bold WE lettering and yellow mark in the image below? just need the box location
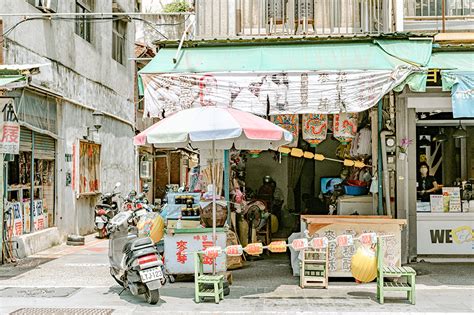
[416,213,474,255]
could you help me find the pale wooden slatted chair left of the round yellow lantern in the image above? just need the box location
[300,249,329,288]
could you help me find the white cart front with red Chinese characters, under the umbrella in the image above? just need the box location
[164,230,226,274]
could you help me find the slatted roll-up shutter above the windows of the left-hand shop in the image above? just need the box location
[20,127,56,160]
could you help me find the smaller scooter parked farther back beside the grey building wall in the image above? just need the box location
[95,183,120,238]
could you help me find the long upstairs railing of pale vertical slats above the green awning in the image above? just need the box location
[195,0,391,38]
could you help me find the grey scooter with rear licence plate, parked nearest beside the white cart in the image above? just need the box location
[108,188,166,304]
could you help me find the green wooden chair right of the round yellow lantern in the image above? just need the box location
[377,239,416,304]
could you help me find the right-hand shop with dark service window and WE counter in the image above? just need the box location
[397,52,474,259]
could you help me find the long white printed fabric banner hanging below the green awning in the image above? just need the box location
[140,66,412,117]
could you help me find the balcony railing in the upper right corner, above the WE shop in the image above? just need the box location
[404,0,474,31]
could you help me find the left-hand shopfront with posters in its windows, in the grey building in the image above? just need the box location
[5,90,57,236]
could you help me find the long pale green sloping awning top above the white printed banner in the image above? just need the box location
[139,40,432,73]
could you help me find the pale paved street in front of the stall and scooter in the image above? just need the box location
[0,237,474,314]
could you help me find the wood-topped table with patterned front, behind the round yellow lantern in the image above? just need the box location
[301,215,407,277]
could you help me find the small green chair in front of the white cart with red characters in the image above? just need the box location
[194,253,224,304]
